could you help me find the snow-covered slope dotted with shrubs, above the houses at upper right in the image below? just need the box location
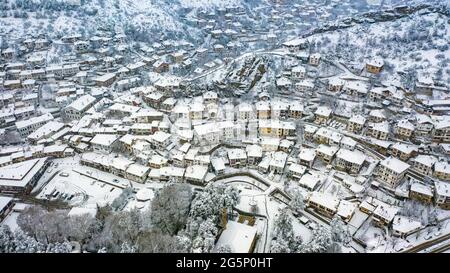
[308,13,450,82]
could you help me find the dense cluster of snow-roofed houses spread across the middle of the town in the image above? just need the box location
[0,1,450,251]
